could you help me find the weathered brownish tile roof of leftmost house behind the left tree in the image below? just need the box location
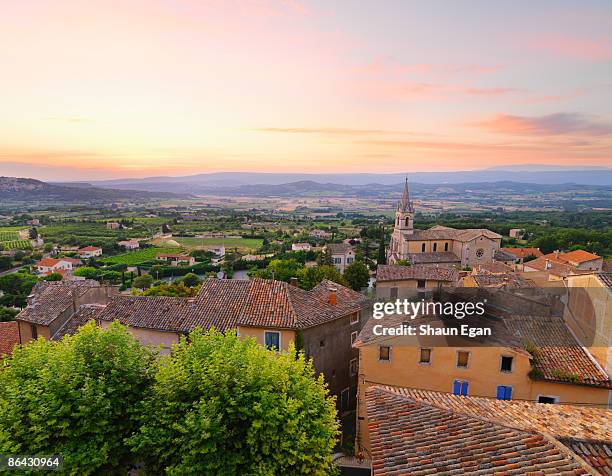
[17,279,100,326]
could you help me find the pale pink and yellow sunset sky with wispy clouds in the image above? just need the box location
[0,0,612,180]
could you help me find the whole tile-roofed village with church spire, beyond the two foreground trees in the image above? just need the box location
[0,180,612,474]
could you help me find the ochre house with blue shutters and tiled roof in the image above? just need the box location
[355,315,612,451]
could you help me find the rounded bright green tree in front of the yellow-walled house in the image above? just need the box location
[128,330,338,475]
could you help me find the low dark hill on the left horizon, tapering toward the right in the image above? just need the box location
[0,177,186,203]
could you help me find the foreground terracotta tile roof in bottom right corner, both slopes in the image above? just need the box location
[361,385,612,476]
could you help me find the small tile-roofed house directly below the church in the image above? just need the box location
[376,265,459,299]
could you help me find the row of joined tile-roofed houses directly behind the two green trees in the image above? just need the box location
[17,279,365,410]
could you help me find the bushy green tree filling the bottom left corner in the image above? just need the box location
[0,322,155,474]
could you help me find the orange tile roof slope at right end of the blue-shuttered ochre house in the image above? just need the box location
[504,316,612,388]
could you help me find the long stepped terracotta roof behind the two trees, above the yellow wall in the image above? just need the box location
[97,279,363,332]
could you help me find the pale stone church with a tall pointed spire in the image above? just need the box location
[387,178,502,268]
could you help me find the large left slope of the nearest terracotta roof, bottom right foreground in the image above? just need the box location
[366,386,588,475]
